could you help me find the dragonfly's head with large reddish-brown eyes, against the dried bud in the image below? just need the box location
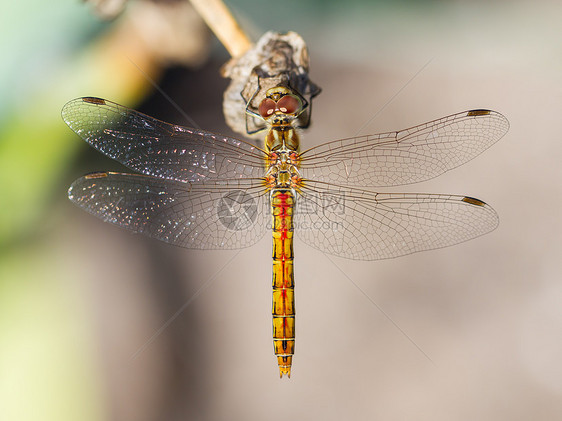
[258,86,304,126]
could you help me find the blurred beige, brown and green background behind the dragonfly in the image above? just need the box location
[0,0,562,421]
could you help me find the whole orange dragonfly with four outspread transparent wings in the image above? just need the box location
[62,90,509,377]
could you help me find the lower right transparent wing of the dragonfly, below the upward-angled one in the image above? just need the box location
[295,182,499,260]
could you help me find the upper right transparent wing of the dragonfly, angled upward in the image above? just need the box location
[301,110,509,187]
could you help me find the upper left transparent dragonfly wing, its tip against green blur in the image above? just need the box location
[62,97,265,182]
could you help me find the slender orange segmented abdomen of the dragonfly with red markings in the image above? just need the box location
[271,189,295,377]
